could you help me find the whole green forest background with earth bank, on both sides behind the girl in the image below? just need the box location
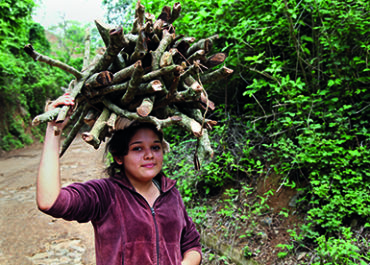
[0,0,370,264]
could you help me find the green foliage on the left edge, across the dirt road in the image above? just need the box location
[0,0,71,150]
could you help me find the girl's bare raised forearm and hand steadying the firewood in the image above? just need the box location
[36,94,74,210]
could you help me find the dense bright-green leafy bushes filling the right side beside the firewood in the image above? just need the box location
[143,0,370,262]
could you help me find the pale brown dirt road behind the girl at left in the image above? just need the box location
[0,137,104,265]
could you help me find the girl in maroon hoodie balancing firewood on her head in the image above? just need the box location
[36,94,201,265]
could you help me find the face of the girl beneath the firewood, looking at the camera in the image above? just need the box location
[115,128,163,186]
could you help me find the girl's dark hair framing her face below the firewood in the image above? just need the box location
[105,121,163,177]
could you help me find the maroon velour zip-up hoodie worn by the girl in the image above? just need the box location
[44,174,201,265]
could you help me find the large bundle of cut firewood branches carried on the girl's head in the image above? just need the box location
[24,0,233,165]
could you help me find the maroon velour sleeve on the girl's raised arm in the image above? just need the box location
[39,179,114,223]
